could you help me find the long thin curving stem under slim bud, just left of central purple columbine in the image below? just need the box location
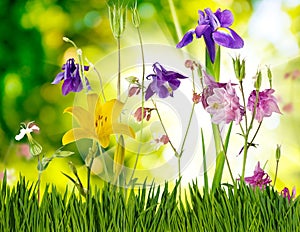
[128,27,146,185]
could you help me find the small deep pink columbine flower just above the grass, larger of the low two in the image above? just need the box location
[245,162,272,189]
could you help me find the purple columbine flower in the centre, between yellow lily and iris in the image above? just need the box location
[145,62,187,101]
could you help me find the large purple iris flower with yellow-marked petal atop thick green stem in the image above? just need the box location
[176,8,244,63]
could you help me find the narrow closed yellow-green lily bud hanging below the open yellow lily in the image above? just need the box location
[113,135,125,182]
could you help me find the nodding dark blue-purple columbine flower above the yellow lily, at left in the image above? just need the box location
[51,58,91,95]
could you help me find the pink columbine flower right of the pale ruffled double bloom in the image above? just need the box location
[247,89,281,122]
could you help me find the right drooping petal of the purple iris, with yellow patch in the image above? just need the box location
[212,27,244,49]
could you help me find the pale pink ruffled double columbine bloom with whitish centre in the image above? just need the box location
[206,82,244,124]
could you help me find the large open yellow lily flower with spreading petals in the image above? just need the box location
[62,94,135,148]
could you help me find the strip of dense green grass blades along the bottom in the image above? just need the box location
[0,177,300,232]
